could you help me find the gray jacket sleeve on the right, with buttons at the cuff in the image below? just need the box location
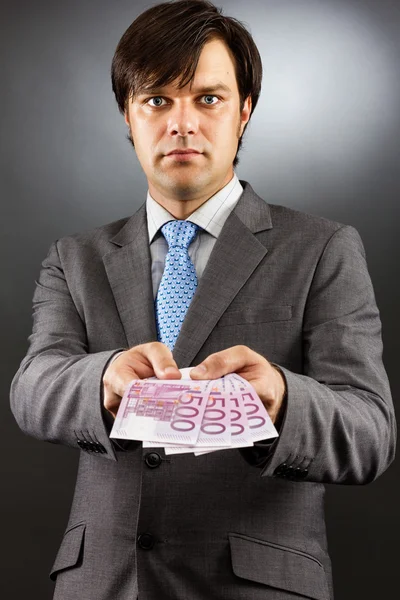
[254,226,396,484]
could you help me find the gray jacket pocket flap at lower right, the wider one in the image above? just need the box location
[228,533,330,600]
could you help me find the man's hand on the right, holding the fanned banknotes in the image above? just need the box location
[190,346,286,423]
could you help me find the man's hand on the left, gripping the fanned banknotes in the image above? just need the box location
[103,342,182,418]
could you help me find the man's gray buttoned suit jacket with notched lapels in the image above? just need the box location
[11,181,395,600]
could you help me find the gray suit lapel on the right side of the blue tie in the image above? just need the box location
[173,181,272,367]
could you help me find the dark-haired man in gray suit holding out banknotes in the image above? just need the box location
[11,0,395,600]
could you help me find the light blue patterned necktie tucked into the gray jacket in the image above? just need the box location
[155,220,199,350]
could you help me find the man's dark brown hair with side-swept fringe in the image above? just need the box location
[111,0,262,166]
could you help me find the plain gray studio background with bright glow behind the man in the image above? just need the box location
[0,0,400,600]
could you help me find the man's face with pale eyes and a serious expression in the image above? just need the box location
[125,39,251,200]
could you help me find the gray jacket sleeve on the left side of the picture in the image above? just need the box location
[10,242,128,460]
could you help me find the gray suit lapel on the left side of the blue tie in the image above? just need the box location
[103,204,157,347]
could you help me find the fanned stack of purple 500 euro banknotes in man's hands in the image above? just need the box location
[110,368,278,456]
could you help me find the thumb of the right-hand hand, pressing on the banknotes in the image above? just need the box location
[190,346,253,379]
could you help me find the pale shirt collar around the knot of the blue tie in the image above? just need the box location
[146,173,243,244]
